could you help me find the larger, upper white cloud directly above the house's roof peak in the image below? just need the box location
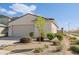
[9,4,36,14]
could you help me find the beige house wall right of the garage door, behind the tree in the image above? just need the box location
[34,21,57,37]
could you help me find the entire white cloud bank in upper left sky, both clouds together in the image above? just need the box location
[0,4,36,16]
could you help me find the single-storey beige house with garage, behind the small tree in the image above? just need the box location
[8,14,58,37]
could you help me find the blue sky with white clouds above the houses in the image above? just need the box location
[0,3,79,30]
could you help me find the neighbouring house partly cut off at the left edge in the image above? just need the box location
[0,15,10,36]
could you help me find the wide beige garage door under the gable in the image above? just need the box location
[12,25,34,36]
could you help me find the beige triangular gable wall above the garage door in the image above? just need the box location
[9,14,36,25]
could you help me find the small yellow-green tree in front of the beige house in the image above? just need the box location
[35,16,46,41]
